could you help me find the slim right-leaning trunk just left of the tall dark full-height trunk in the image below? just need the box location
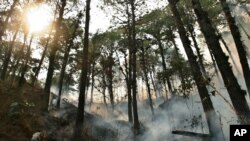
[56,13,82,109]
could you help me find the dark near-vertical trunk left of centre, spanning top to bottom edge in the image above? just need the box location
[72,0,91,141]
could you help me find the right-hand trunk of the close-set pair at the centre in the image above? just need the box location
[130,0,140,131]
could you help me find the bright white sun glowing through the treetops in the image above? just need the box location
[26,4,53,33]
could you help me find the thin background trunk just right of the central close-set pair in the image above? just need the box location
[141,43,155,117]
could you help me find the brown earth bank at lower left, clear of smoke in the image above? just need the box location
[0,81,45,141]
